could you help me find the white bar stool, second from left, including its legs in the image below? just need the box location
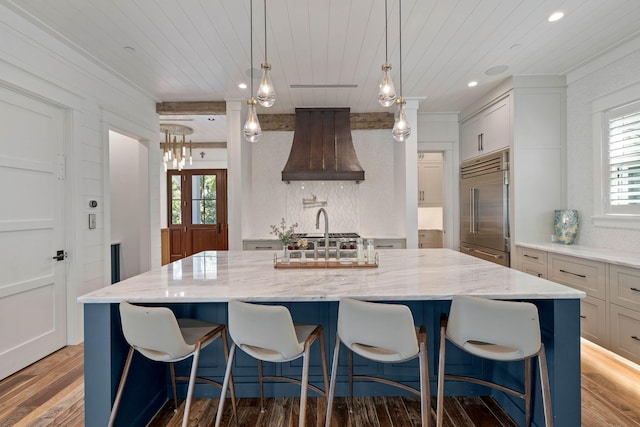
[216,300,329,427]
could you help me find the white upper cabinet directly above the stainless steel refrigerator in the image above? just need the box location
[461,96,511,161]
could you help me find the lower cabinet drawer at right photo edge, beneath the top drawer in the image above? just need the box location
[609,304,640,363]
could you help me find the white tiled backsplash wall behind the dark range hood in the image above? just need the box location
[243,130,404,238]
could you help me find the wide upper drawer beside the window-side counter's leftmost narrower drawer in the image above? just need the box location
[548,254,606,300]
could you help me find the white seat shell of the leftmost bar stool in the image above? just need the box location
[120,302,195,362]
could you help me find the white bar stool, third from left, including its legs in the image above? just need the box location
[325,298,431,427]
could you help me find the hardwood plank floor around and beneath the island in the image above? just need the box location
[0,342,640,427]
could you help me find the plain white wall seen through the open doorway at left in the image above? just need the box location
[109,132,150,280]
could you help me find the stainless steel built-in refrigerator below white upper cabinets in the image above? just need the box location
[460,150,510,267]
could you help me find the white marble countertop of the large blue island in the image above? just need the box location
[78,249,585,304]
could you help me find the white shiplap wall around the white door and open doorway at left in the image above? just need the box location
[0,4,160,344]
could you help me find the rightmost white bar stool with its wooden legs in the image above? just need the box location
[437,295,553,427]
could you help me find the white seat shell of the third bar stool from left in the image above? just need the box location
[338,298,419,362]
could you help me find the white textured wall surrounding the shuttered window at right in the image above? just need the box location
[566,38,640,252]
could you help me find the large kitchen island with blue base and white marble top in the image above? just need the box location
[78,249,584,426]
